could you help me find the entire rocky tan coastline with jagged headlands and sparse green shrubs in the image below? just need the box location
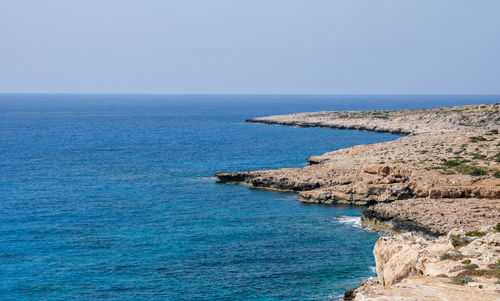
[216,103,500,301]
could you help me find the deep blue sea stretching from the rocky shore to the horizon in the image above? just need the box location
[0,94,500,300]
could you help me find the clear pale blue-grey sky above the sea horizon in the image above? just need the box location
[0,0,500,94]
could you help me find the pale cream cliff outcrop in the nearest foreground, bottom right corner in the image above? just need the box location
[345,227,500,301]
